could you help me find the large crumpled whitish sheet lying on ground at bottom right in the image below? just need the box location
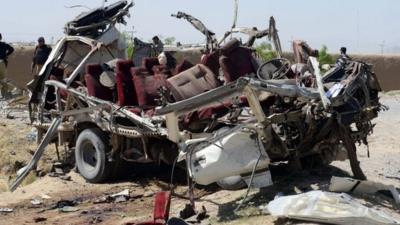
[267,191,400,225]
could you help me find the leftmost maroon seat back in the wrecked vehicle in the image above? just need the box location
[85,64,113,101]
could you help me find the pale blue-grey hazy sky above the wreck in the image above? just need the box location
[0,0,400,54]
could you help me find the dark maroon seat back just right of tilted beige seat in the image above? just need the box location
[219,39,257,83]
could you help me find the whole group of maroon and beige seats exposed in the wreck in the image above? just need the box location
[85,40,256,128]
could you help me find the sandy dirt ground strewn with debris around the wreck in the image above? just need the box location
[0,92,400,225]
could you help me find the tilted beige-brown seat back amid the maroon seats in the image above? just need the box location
[168,64,220,101]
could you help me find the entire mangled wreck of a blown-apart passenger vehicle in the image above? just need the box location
[11,1,381,193]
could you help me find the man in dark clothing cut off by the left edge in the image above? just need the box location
[0,33,14,98]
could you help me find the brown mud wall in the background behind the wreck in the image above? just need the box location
[8,47,400,91]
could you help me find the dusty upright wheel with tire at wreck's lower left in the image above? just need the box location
[75,128,114,183]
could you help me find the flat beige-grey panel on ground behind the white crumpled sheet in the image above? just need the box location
[329,176,400,204]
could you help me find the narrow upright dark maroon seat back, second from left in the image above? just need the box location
[116,60,138,106]
